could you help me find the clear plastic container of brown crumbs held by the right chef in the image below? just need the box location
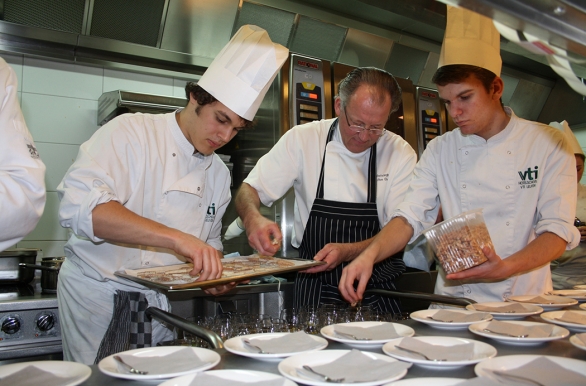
[423,209,494,274]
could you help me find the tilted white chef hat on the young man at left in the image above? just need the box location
[197,25,289,121]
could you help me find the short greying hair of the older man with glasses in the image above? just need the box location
[336,67,402,116]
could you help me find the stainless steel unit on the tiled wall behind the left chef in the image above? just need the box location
[98,90,187,126]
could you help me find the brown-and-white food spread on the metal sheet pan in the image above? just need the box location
[131,255,295,284]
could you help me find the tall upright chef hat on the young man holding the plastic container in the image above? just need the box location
[438,5,502,76]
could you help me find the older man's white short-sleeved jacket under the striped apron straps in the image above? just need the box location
[244,119,417,247]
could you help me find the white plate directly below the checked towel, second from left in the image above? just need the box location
[98,346,220,380]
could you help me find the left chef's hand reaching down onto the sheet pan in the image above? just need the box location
[173,233,223,281]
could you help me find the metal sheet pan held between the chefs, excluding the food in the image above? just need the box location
[114,256,326,291]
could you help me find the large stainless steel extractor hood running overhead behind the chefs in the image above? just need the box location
[0,0,586,124]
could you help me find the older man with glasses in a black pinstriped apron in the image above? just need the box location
[236,68,416,313]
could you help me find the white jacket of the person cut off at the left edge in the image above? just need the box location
[0,58,46,251]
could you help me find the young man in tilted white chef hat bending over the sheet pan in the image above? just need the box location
[58,25,288,364]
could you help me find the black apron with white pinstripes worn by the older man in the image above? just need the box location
[294,119,405,313]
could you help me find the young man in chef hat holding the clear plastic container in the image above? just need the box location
[339,7,580,302]
